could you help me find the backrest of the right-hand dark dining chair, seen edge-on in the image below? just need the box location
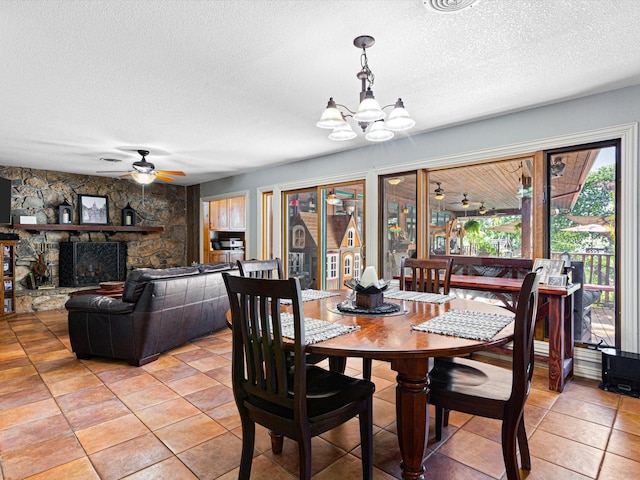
[509,272,540,409]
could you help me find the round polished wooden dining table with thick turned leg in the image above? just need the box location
[296,291,513,479]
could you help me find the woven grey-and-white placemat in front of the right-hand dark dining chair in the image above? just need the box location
[411,310,513,341]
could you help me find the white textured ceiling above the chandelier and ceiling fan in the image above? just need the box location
[0,0,640,185]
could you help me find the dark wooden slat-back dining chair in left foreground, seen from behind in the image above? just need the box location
[223,274,375,479]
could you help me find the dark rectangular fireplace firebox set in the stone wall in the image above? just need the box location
[58,242,127,287]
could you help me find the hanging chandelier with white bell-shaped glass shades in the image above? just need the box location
[316,35,416,142]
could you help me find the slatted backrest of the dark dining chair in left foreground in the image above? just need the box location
[223,273,306,412]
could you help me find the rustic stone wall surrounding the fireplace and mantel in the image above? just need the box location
[0,166,187,313]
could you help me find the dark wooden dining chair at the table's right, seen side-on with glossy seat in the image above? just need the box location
[429,272,540,480]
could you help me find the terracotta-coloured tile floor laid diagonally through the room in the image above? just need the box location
[0,311,640,480]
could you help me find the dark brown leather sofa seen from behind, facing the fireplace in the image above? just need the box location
[65,263,237,366]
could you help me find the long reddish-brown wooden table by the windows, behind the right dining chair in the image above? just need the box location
[444,275,581,392]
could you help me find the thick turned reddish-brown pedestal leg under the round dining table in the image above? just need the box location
[391,358,429,480]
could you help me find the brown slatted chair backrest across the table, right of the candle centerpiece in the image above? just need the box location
[400,257,453,295]
